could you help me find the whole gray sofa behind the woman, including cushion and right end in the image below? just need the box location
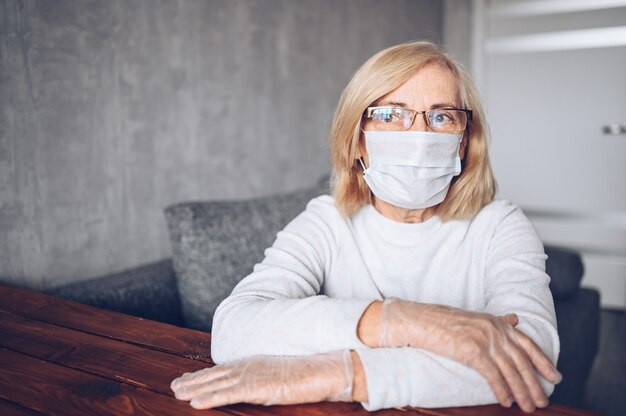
[49,183,599,407]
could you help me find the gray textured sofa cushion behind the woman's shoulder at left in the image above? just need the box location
[165,181,328,331]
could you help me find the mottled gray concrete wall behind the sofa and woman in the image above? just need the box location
[0,0,442,289]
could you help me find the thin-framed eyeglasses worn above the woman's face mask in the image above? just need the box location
[363,107,472,133]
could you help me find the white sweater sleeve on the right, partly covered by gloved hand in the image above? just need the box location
[357,205,559,411]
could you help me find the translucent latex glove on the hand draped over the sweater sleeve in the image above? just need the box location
[380,298,561,412]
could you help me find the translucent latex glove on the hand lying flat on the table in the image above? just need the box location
[171,350,354,409]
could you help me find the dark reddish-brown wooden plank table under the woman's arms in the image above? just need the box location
[0,285,604,416]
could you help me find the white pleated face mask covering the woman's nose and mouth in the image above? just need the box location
[359,131,463,209]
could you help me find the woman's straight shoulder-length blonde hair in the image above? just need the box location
[330,42,496,221]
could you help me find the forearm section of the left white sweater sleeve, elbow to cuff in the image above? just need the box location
[211,296,371,364]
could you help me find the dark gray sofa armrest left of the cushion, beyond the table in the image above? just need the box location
[47,259,184,326]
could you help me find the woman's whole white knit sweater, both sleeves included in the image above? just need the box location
[211,196,559,410]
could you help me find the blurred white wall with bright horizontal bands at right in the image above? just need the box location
[468,0,626,308]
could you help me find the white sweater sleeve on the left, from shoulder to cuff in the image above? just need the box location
[211,197,373,364]
